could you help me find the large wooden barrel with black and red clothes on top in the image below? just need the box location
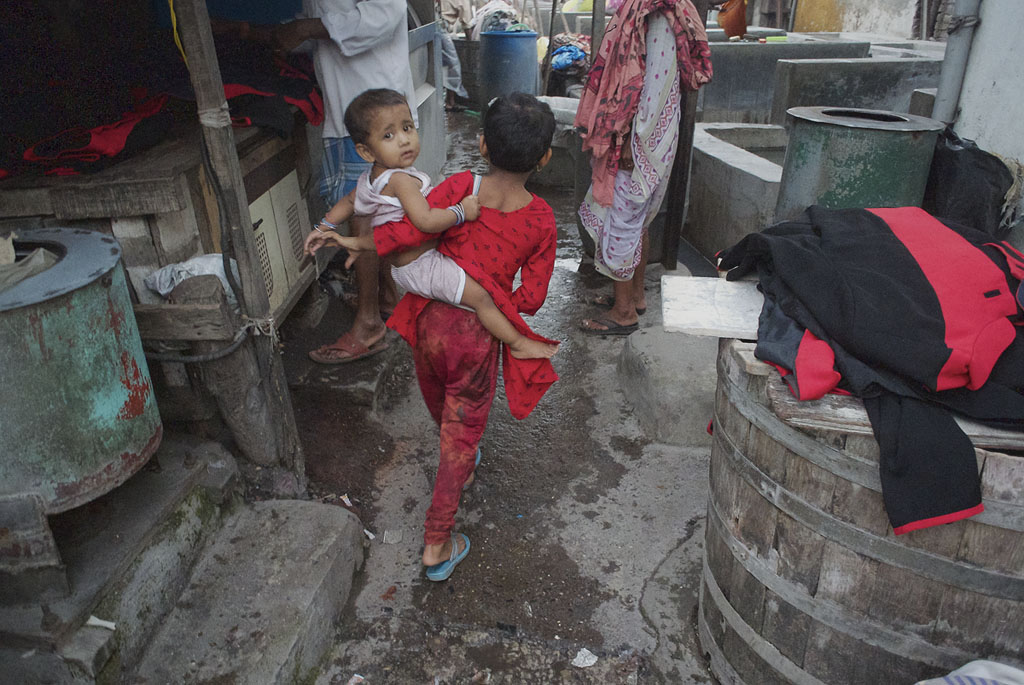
[698,341,1024,685]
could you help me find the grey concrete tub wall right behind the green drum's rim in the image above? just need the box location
[770,57,942,124]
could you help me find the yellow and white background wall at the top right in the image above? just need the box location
[794,0,918,38]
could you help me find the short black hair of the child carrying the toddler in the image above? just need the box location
[483,93,555,172]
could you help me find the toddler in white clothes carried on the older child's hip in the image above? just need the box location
[306,88,558,359]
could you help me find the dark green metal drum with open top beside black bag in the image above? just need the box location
[775,106,944,221]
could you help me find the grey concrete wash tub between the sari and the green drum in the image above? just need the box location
[682,123,786,259]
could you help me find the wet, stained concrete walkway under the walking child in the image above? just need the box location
[276,109,714,685]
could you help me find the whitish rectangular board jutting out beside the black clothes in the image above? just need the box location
[662,274,764,340]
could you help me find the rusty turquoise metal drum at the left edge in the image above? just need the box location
[0,228,162,514]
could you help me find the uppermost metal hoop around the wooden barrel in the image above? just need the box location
[719,360,1024,532]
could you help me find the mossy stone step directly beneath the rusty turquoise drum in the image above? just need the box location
[0,433,237,683]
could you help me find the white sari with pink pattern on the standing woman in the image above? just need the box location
[580,13,682,281]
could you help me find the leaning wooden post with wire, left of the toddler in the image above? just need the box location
[167,0,305,487]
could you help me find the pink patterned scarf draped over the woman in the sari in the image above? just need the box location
[574,0,712,207]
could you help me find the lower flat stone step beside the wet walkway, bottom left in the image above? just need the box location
[133,500,362,685]
